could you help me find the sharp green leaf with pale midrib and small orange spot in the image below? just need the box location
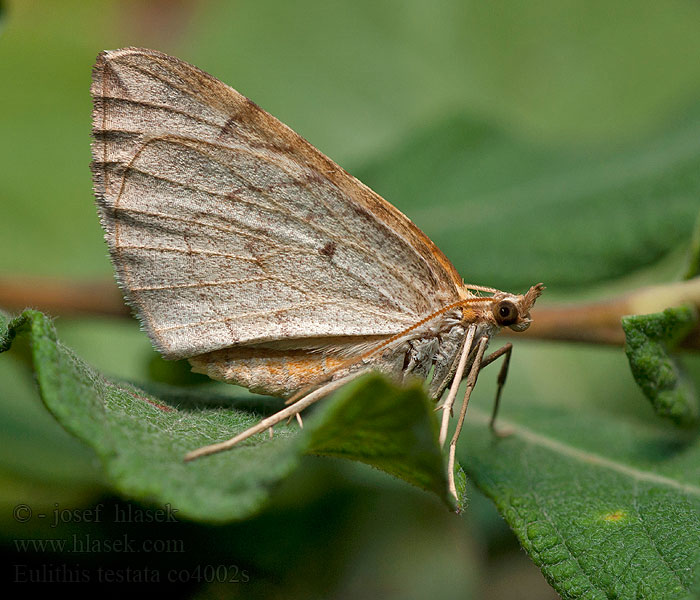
[458,405,700,599]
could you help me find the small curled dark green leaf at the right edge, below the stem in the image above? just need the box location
[622,306,699,427]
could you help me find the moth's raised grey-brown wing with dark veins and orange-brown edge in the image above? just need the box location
[91,48,461,358]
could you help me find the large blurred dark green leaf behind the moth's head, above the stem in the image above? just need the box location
[354,113,700,291]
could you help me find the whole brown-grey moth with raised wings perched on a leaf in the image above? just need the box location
[91,48,544,497]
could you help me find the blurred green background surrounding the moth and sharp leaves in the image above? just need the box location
[0,0,700,599]
